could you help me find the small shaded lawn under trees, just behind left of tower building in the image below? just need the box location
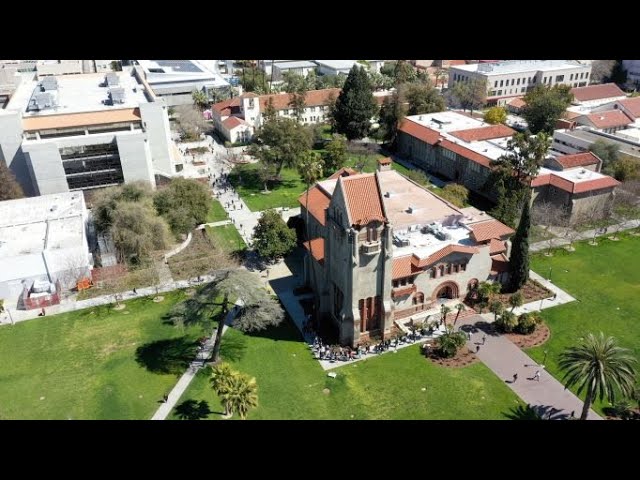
[229,163,305,212]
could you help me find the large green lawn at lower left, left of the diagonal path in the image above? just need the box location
[0,292,208,420]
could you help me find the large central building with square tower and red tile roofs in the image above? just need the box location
[299,163,514,346]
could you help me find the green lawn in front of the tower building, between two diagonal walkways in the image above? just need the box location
[173,322,518,419]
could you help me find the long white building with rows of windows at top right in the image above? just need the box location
[449,60,591,105]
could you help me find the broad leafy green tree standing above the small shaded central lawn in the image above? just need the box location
[248,117,312,176]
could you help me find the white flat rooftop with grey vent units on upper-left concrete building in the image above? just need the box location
[6,72,148,118]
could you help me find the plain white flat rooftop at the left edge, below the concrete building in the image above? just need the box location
[0,192,86,260]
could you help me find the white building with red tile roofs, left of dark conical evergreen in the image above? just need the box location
[211,88,340,143]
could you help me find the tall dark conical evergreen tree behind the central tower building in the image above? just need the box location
[333,65,377,140]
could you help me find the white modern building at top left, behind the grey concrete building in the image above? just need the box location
[134,60,230,107]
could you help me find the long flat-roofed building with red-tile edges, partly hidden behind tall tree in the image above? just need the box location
[398,111,618,223]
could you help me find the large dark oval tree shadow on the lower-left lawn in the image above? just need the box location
[136,337,198,375]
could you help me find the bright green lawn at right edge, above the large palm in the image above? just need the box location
[528,234,640,413]
